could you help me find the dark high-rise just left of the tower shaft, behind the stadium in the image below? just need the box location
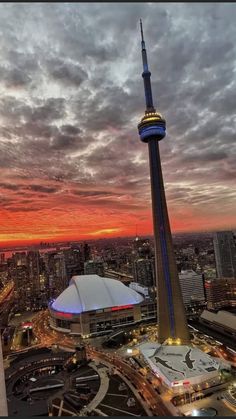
[133,258,155,287]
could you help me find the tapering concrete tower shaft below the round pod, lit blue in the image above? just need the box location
[148,139,189,343]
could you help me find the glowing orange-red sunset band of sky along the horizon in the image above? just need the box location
[0,200,235,247]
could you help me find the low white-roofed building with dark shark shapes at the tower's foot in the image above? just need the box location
[139,342,230,395]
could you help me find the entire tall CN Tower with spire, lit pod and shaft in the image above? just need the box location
[138,19,190,345]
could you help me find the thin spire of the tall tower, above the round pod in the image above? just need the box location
[140,19,155,111]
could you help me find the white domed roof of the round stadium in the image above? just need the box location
[51,275,143,314]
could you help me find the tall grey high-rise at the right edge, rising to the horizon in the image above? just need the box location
[213,231,236,278]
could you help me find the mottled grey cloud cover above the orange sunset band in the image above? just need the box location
[0,3,236,225]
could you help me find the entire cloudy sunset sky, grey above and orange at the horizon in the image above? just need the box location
[0,3,236,244]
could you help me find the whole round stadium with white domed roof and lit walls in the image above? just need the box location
[49,275,144,337]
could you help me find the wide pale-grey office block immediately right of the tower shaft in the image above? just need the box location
[179,269,205,307]
